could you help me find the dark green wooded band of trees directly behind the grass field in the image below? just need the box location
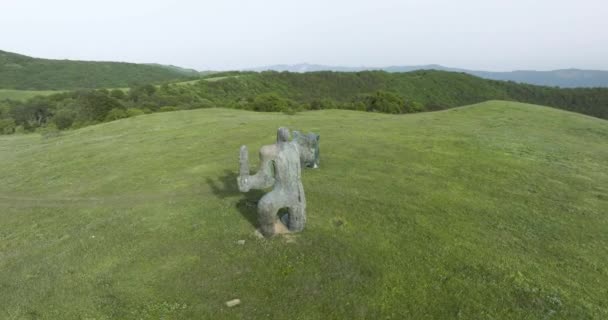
[0,71,608,134]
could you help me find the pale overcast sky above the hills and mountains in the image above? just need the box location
[0,0,608,70]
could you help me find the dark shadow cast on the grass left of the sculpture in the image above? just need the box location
[207,170,265,228]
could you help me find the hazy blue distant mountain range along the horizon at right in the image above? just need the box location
[249,63,608,88]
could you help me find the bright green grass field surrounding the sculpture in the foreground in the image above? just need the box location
[0,101,608,319]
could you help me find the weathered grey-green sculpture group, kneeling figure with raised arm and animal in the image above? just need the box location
[237,128,319,237]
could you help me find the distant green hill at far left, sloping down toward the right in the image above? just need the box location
[0,51,198,90]
